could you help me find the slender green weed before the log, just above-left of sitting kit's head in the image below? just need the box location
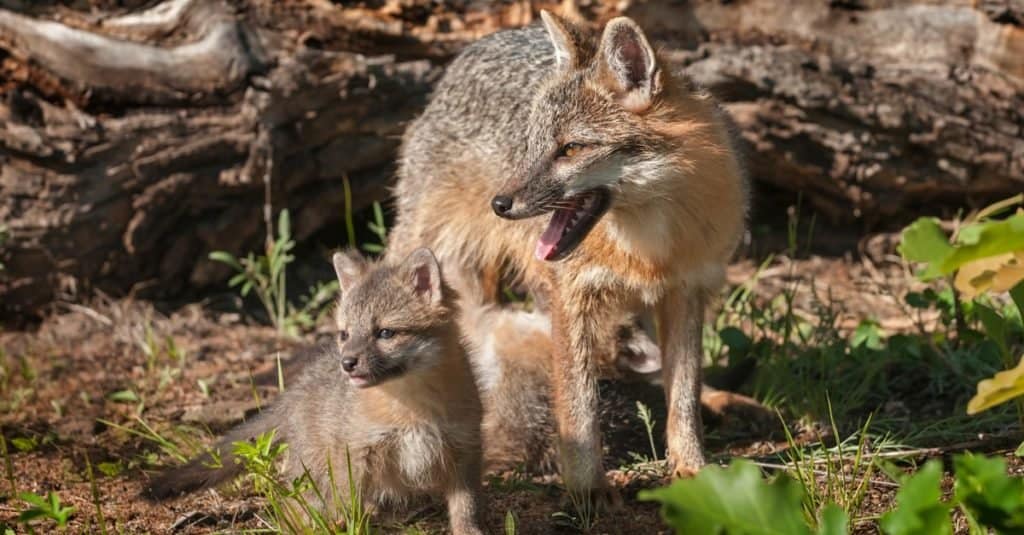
[210,210,338,336]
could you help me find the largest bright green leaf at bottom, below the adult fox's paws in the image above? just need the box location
[638,460,815,535]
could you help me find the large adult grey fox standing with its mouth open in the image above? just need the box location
[389,12,748,500]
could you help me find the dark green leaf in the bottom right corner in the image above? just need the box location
[953,453,1024,534]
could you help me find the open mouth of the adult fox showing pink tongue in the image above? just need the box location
[534,189,611,261]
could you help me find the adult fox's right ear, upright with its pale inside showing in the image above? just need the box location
[598,16,662,113]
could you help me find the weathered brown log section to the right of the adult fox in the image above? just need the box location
[632,0,1024,222]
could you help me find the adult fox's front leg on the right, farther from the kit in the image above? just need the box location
[657,288,706,478]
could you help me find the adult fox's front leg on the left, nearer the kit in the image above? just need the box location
[551,284,618,505]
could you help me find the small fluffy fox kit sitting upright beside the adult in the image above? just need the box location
[141,248,481,535]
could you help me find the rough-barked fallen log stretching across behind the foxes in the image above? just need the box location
[0,0,1024,318]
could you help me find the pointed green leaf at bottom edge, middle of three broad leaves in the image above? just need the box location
[880,460,953,535]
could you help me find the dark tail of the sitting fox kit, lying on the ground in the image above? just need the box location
[142,410,282,501]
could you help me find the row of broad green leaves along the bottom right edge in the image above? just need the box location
[639,453,1024,535]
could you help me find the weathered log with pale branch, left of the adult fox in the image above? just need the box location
[0,3,437,316]
